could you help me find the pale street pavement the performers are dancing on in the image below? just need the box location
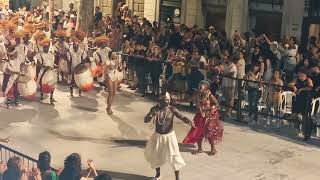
[0,86,320,180]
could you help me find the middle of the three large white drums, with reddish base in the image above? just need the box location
[37,69,58,94]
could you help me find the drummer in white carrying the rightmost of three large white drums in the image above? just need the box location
[67,37,87,97]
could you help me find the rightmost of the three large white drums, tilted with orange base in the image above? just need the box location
[74,65,93,92]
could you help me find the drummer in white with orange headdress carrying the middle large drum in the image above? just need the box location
[34,39,57,105]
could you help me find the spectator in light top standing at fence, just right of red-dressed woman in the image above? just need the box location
[222,51,237,118]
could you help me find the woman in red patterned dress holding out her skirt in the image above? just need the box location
[183,80,223,156]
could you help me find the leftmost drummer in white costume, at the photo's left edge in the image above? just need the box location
[2,46,21,108]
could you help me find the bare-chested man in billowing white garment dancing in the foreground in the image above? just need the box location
[144,93,195,180]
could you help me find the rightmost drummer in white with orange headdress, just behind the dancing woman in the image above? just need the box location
[93,36,111,91]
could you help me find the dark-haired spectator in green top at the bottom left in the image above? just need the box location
[38,151,58,180]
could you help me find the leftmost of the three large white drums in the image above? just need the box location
[17,75,37,100]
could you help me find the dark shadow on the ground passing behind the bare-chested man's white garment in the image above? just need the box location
[112,139,194,152]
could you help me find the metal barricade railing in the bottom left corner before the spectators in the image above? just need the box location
[0,144,57,172]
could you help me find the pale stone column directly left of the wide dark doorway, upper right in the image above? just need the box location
[226,0,249,38]
